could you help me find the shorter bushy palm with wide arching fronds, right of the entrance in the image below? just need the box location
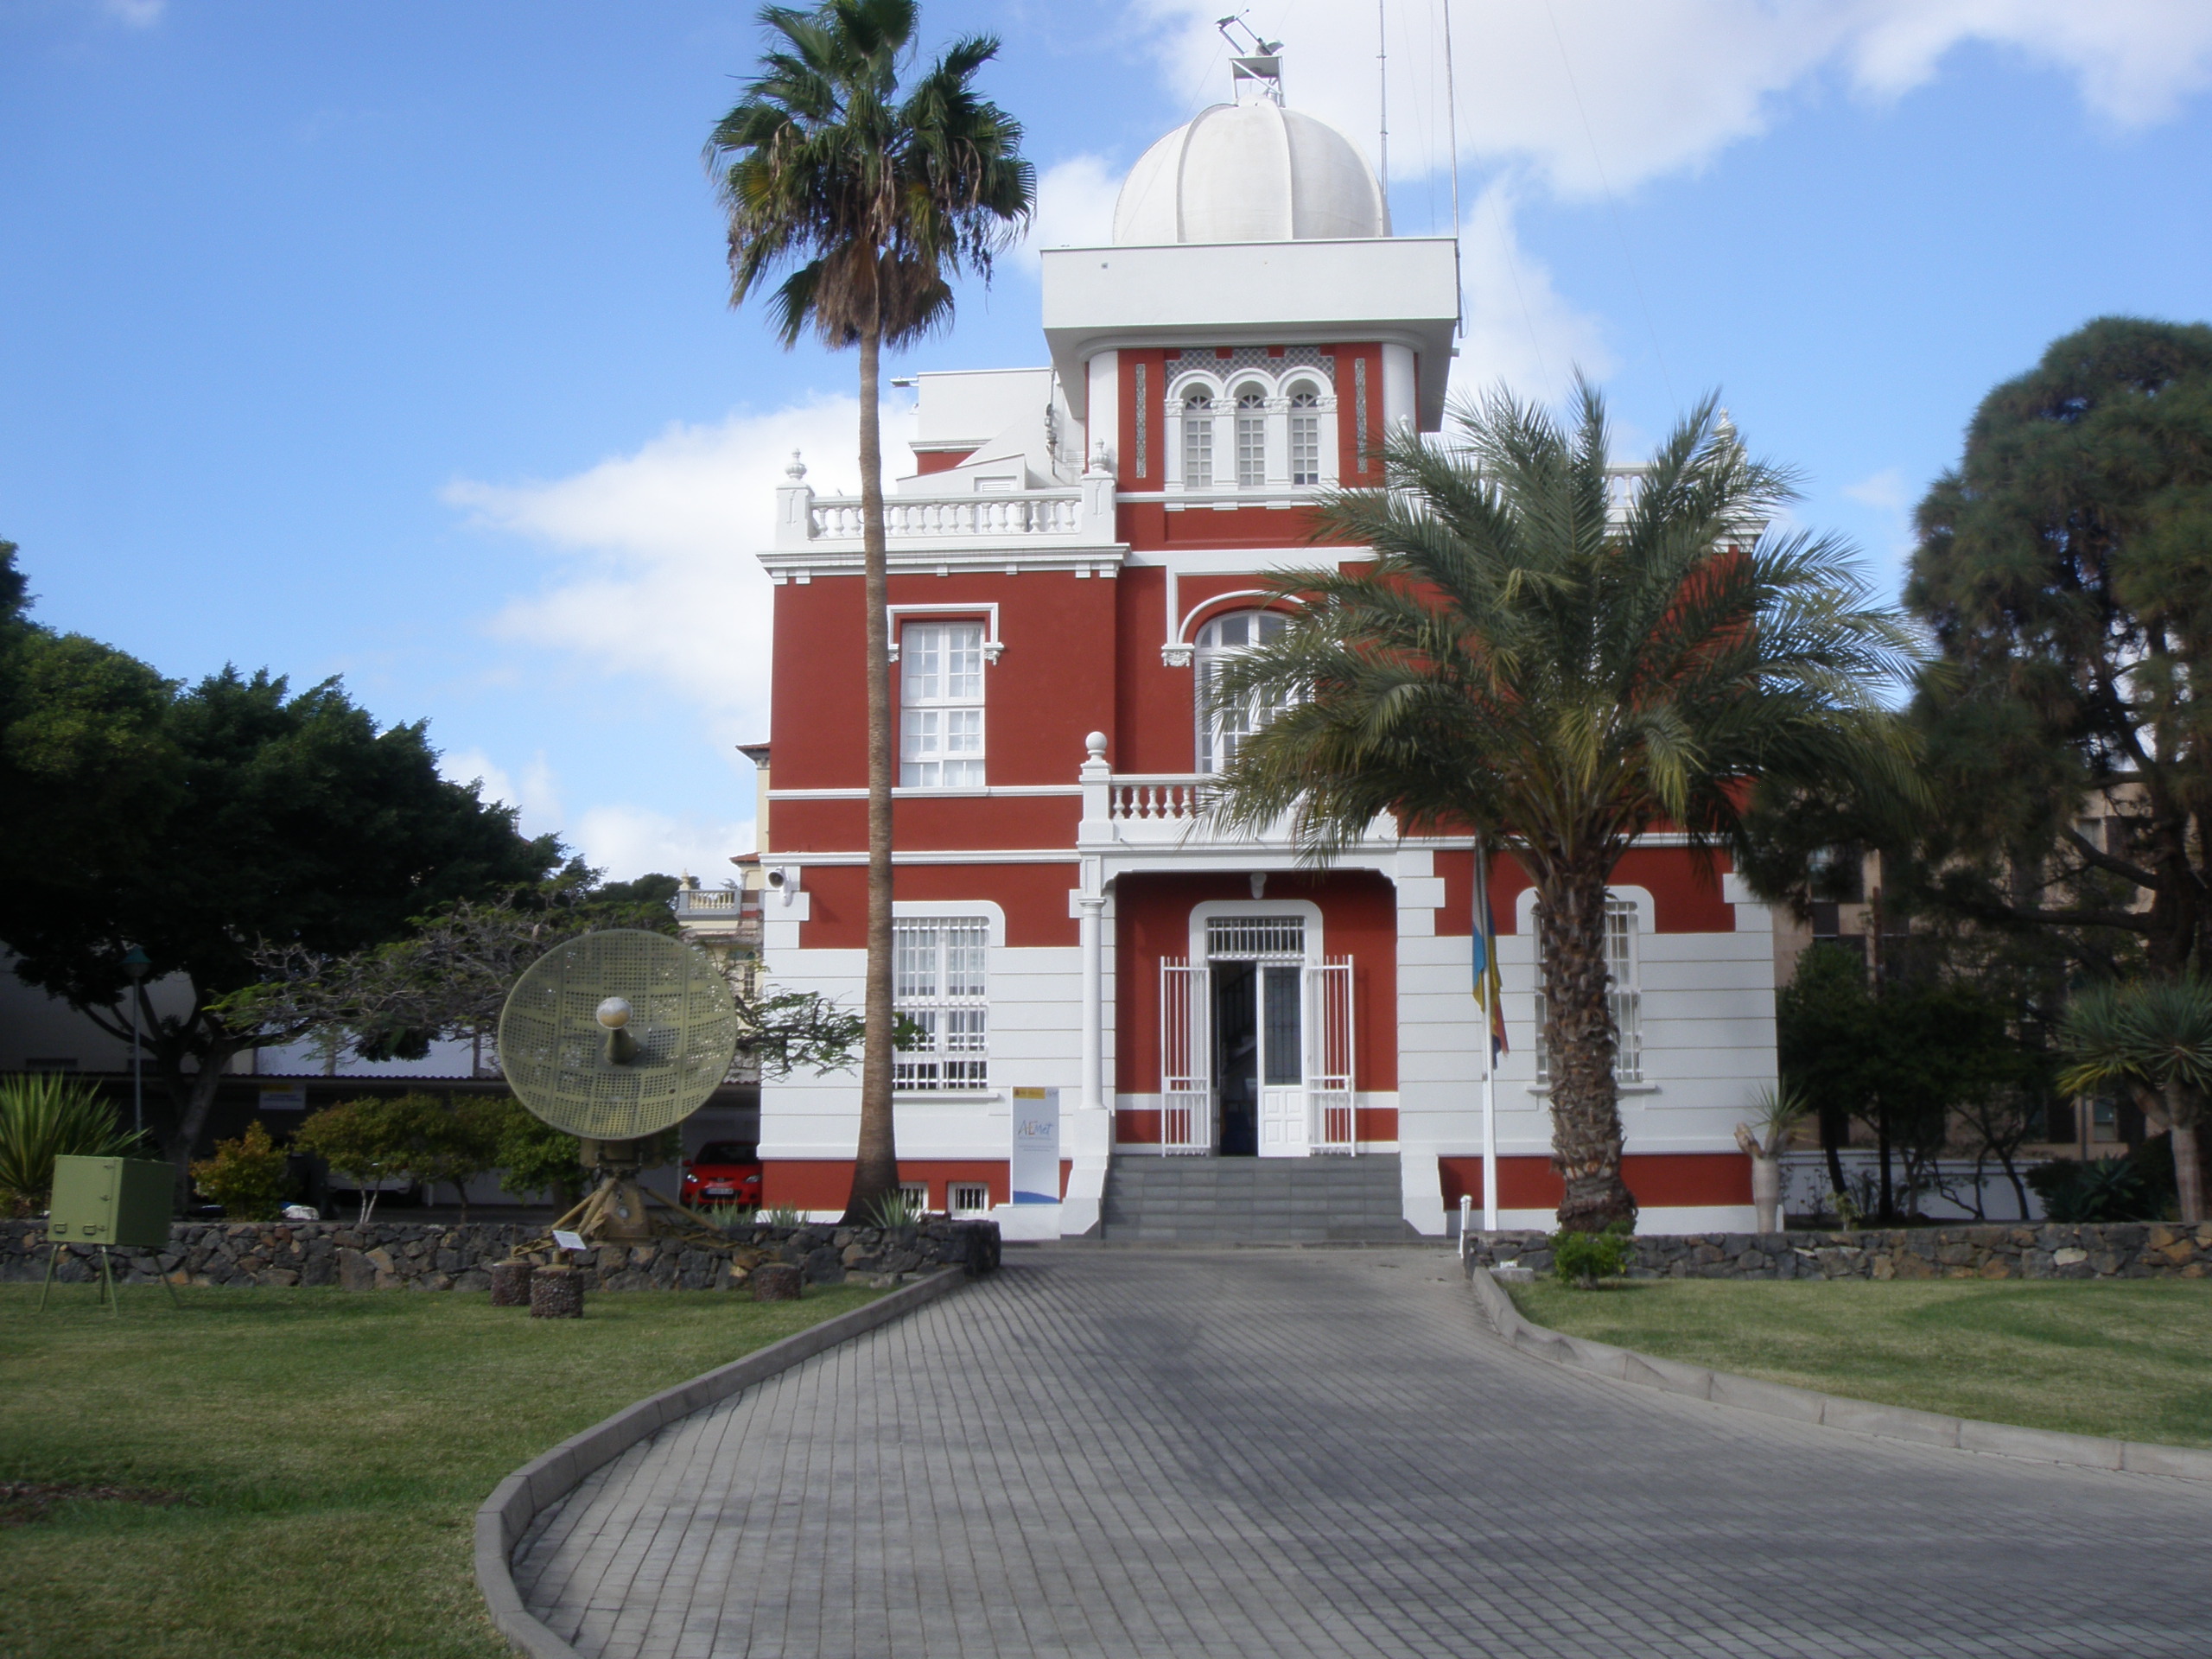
[1214,383,1916,1230]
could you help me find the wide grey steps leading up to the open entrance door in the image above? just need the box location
[1099,1153,1415,1243]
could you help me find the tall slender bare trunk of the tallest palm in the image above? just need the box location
[845,327,898,1224]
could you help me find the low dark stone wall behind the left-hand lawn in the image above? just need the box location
[0,1219,998,1289]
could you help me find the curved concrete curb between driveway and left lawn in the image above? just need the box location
[475,1268,967,1659]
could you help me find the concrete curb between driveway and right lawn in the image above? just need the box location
[1466,1263,2212,1480]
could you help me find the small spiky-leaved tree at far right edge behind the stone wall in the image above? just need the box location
[2059,976,2212,1225]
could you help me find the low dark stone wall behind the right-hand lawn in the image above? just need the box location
[1469,1221,2212,1279]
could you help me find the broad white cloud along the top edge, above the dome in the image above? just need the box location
[1133,0,2212,197]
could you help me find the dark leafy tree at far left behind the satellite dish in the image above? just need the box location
[0,557,562,1181]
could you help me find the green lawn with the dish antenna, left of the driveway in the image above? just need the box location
[0,1285,874,1659]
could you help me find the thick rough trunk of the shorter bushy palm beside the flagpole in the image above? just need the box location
[1535,858,1637,1232]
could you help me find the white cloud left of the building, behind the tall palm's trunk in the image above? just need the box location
[445,398,905,741]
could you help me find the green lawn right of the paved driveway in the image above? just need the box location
[1509,1279,2212,1446]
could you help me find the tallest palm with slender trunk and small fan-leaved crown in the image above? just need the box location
[706,0,1038,1221]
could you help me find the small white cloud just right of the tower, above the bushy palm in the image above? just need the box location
[1451,181,1615,403]
